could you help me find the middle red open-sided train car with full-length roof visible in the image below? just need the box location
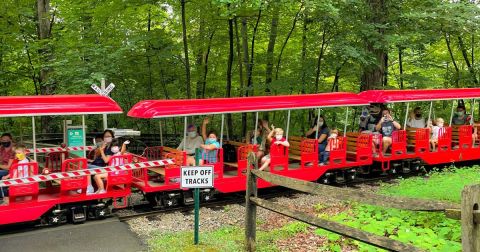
[128,92,372,206]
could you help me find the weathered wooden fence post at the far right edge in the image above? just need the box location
[461,184,480,252]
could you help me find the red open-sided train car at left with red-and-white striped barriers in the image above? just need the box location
[0,95,131,225]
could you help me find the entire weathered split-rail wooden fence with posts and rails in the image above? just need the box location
[245,155,480,252]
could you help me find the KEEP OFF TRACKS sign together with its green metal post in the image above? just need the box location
[180,149,214,245]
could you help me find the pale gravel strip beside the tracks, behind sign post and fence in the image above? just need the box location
[125,182,384,241]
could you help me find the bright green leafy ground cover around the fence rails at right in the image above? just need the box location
[316,166,480,251]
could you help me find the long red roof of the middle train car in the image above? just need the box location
[128,92,369,118]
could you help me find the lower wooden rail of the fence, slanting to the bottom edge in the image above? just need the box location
[250,197,421,251]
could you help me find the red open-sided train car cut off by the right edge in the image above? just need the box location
[359,88,480,170]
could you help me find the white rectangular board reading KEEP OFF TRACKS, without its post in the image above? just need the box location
[180,166,213,188]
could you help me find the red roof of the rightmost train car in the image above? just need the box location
[359,88,480,103]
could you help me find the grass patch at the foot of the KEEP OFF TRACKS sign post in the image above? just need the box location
[149,222,308,252]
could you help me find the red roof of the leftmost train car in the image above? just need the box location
[0,94,122,117]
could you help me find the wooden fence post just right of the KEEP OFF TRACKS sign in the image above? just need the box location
[245,152,258,252]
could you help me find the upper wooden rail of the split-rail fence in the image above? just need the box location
[252,170,460,211]
